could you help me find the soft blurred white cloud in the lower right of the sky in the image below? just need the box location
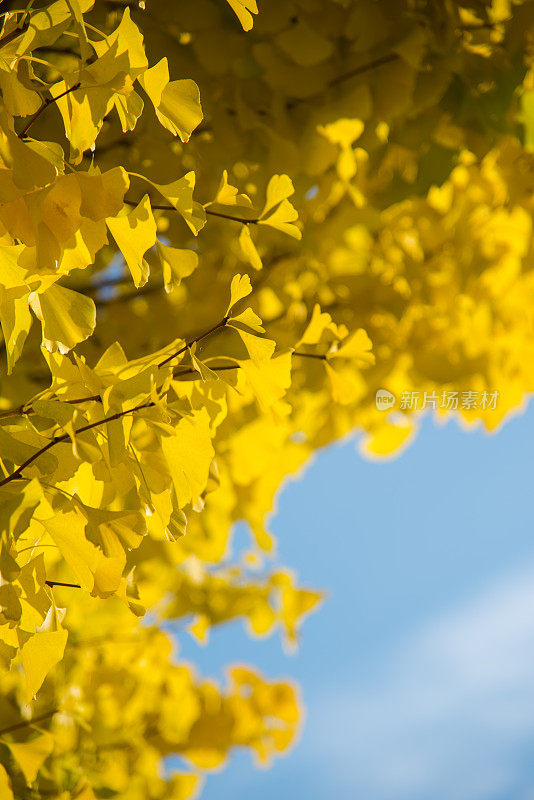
[308,567,534,800]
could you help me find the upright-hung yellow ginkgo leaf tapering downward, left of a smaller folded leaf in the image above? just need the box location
[106,194,157,287]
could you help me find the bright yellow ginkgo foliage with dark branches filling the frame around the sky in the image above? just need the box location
[0,0,534,800]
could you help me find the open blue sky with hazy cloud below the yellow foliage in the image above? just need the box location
[171,405,534,800]
